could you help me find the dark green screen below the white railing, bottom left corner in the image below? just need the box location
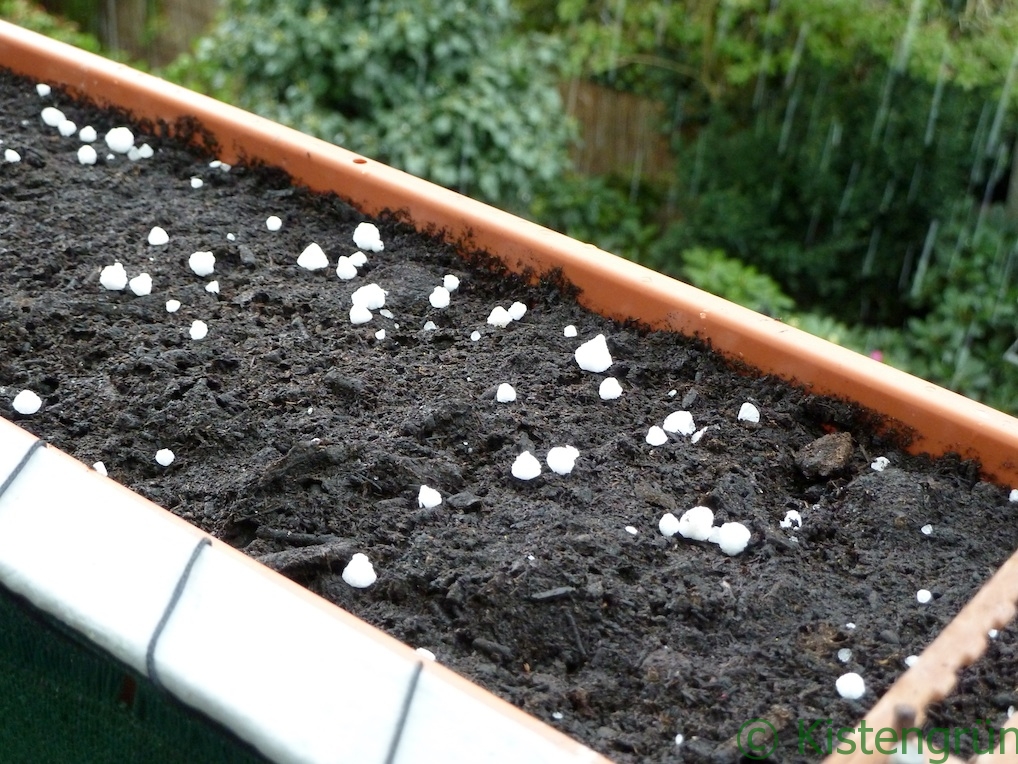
[0,587,267,764]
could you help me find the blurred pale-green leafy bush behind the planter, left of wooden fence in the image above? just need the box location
[168,0,573,209]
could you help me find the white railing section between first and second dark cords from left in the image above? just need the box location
[0,435,206,671]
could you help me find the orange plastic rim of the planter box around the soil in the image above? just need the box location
[0,21,1018,761]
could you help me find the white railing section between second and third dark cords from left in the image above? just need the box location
[149,545,417,764]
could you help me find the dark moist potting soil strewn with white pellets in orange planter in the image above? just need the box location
[0,68,1018,762]
